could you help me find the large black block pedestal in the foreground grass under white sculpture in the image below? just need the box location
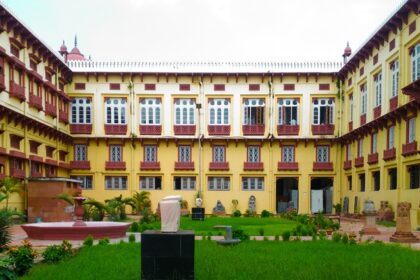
[141,230,194,280]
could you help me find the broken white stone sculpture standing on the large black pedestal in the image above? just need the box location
[159,195,182,232]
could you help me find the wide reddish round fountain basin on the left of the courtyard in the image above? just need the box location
[22,222,130,240]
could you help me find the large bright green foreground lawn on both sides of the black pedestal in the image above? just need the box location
[23,241,420,280]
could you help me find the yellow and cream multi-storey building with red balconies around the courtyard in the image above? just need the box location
[0,1,420,227]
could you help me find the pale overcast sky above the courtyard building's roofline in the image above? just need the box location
[1,0,401,61]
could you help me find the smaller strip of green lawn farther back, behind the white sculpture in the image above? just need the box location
[139,217,297,236]
